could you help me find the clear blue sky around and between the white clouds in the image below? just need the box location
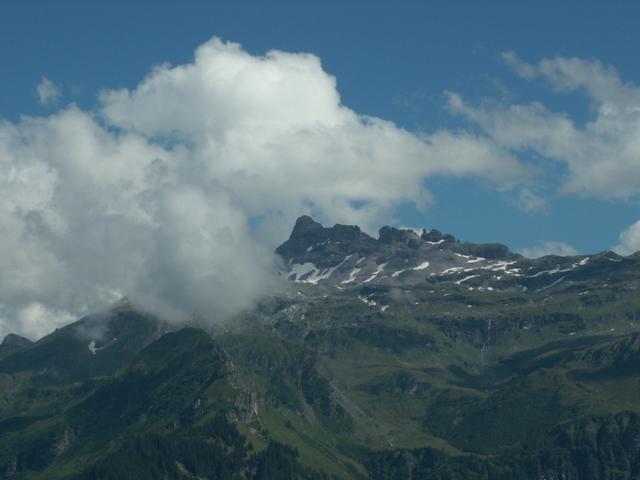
[0,1,640,253]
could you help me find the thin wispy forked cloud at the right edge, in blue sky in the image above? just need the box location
[448,53,640,199]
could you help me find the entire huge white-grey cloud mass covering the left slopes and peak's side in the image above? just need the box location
[0,39,528,336]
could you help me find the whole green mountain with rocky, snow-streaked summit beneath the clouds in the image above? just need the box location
[0,217,640,480]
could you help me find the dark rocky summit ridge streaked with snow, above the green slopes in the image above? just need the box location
[276,216,633,291]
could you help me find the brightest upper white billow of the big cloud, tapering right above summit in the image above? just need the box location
[102,39,523,229]
